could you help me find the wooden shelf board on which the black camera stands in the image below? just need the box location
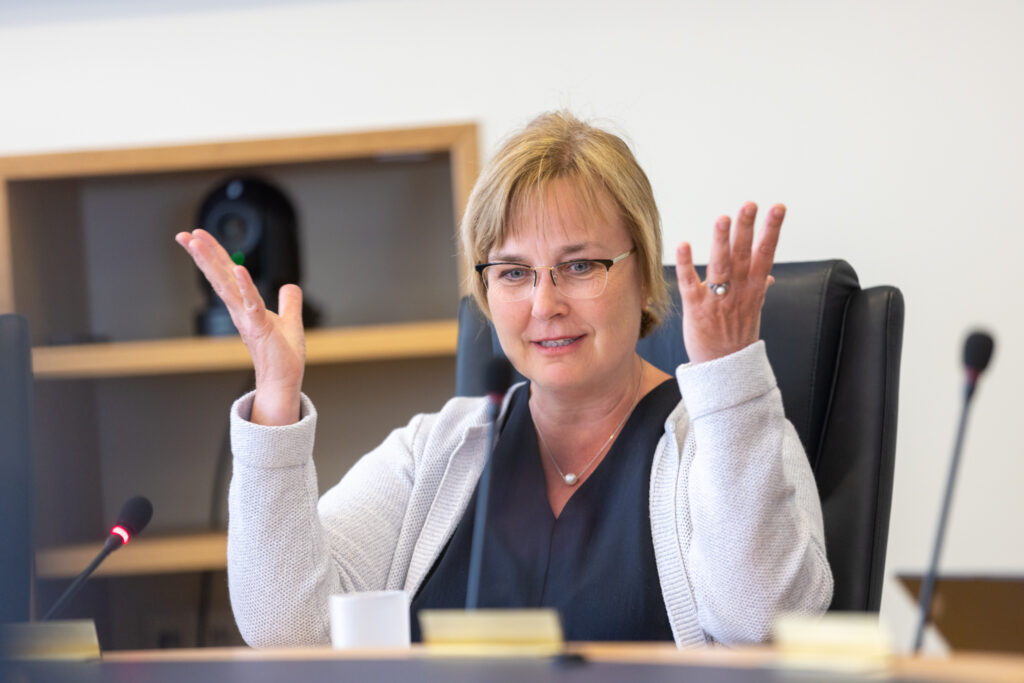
[32,319,459,379]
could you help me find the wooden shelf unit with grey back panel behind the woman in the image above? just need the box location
[0,124,478,647]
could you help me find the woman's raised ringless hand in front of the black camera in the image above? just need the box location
[174,229,306,425]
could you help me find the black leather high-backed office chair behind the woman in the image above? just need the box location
[456,260,903,611]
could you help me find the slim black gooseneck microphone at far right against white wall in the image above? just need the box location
[913,332,995,652]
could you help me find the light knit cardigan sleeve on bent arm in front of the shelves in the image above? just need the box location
[227,393,423,646]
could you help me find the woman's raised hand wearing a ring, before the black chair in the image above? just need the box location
[676,202,785,362]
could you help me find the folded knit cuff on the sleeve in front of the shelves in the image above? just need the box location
[231,391,316,468]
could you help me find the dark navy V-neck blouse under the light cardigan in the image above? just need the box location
[412,380,680,641]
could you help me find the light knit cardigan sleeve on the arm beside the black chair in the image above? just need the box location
[677,342,833,643]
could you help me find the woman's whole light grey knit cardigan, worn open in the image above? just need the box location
[227,342,833,647]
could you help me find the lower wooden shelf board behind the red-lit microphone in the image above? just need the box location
[36,532,227,579]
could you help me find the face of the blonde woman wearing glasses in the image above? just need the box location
[487,180,644,393]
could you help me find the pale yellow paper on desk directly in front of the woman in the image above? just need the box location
[418,609,565,656]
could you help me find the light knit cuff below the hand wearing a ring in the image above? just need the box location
[676,341,776,420]
